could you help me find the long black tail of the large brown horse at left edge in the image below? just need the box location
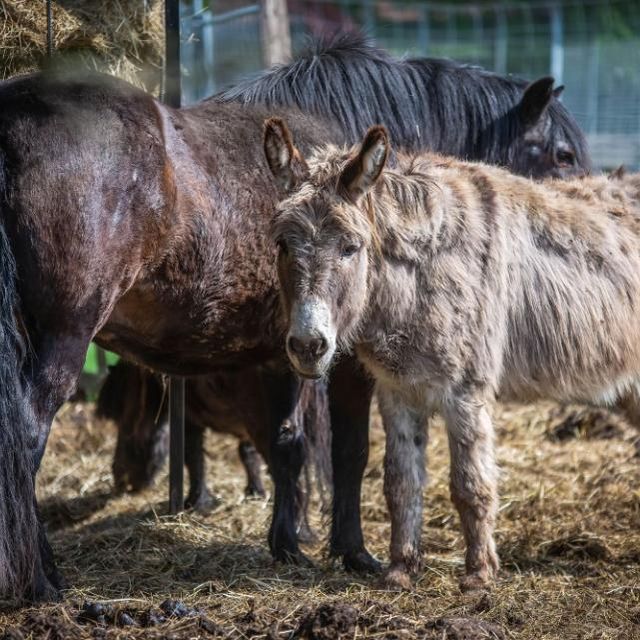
[0,219,39,600]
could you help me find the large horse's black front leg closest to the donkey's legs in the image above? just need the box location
[329,357,381,572]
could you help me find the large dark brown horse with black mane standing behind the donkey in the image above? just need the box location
[0,38,589,597]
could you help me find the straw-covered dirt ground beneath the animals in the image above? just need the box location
[0,398,640,640]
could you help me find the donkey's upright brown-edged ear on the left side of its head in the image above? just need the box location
[263,118,308,193]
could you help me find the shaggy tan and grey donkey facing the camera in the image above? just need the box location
[264,118,640,588]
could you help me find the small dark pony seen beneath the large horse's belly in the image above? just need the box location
[96,360,331,532]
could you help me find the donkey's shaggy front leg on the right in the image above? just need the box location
[444,395,499,591]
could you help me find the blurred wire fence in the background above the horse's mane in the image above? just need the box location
[182,0,640,169]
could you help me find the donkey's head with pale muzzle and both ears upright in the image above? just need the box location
[264,118,389,378]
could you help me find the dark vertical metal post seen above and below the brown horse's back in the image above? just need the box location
[164,0,185,514]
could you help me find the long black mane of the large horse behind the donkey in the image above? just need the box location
[219,33,590,168]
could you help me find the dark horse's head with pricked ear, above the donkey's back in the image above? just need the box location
[507,77,590,179]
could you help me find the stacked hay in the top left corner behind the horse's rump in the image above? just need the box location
[0,0,164,93]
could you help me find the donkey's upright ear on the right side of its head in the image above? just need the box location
[338,125,389,202]
